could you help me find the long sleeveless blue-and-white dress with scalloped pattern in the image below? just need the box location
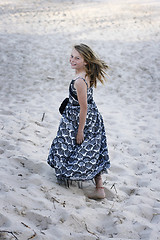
[47,78,110,183]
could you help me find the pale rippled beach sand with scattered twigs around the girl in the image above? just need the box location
[0,0,160,240]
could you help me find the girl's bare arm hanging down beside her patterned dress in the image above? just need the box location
[75,79,87,144]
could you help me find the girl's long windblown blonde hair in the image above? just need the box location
[74,43,108,87]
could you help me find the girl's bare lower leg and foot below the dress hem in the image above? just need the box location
[88,174,105,199]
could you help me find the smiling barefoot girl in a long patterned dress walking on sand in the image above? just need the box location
[47,44,110,199]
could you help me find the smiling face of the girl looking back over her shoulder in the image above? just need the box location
[70,48,86,72]
